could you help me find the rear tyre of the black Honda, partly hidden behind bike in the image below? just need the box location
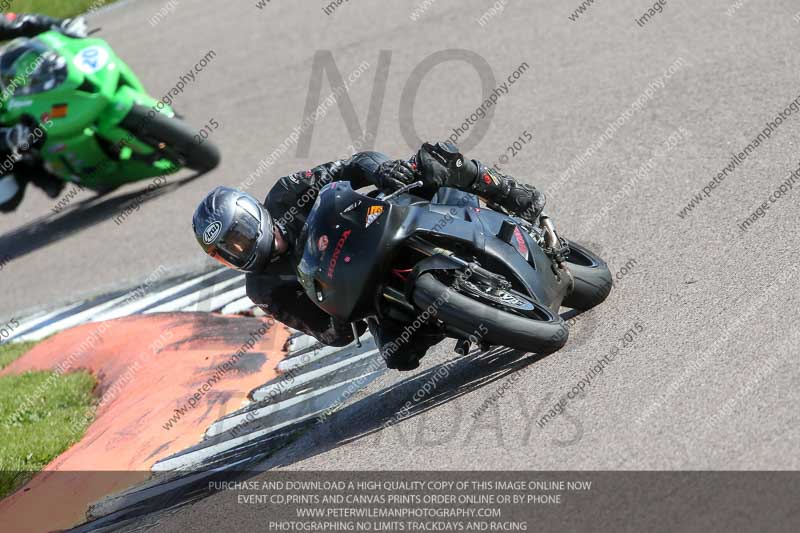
[561,241,613,311]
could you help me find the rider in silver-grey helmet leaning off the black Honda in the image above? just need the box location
[192,142,545,370]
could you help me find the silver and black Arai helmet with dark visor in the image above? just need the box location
[192,187,274,272]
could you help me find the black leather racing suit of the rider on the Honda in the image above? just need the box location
[247,143,544,370]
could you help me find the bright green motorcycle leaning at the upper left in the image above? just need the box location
[0,31,220,202]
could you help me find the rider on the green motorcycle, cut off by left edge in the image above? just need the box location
[0,13,87,213]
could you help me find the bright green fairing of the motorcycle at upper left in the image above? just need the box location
[0,31,180,188]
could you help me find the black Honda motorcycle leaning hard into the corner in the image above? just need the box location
[297,182,612,354]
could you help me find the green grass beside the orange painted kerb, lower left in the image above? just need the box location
[0,343,95,499]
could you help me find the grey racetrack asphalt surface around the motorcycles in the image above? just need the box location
[0,0,800,530]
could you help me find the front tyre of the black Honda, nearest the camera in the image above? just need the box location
[412,273,569,354]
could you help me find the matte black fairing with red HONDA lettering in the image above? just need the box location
[297,182,568,322]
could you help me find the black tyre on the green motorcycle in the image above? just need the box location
[122,105,220,172]
